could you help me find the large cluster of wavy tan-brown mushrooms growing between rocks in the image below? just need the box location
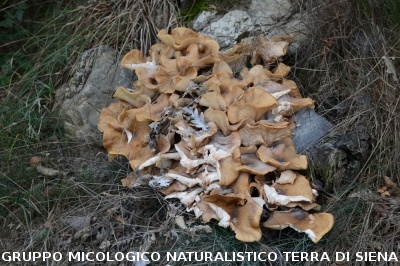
[98,28,333,242]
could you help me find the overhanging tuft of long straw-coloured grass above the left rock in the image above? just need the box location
[63,0,177,53]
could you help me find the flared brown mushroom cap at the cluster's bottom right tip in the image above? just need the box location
[263,209,334,243]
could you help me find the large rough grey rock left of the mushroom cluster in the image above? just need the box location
[54,46,133,146]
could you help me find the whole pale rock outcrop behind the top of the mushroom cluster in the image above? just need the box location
[192,0,308,48]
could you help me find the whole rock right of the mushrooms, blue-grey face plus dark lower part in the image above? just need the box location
[293,110,371,191]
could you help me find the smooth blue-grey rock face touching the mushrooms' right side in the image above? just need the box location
[293,109,333,153]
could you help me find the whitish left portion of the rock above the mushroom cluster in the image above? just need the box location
[202,10,254,48]
